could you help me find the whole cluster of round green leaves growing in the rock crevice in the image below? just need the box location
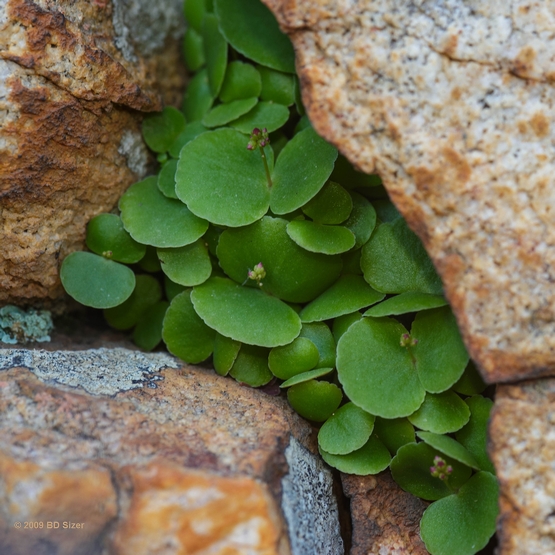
[61,0,497,555]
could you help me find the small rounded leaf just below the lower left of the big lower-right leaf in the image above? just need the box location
[318,403,376,455]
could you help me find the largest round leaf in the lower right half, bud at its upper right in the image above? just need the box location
[337,318,425,418]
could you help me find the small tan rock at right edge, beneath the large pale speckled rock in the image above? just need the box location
[489,379,555,555]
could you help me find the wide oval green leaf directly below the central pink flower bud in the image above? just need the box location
[191,277,301,347]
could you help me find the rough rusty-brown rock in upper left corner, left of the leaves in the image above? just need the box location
[0,0,184,306]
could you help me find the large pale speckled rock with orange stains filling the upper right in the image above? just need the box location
[264,0,555,381]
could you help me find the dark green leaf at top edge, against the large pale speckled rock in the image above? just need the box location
[214,0,295,73]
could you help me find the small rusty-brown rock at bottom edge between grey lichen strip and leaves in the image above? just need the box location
[341,471,428,555]
